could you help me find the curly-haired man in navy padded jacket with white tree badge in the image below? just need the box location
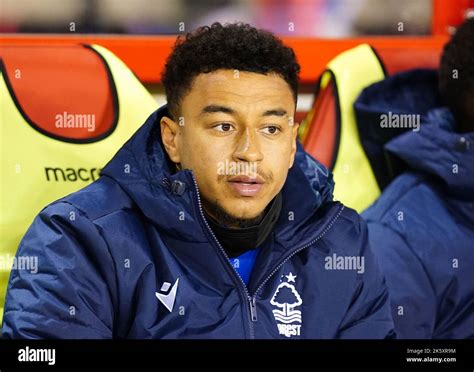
[3,24,393,339]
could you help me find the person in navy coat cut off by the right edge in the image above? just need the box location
[355,19,474,339]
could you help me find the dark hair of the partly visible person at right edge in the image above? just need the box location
[438,18,474,132]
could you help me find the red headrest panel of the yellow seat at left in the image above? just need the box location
[0,45,118,140]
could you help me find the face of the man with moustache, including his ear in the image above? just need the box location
[161,70,298,227]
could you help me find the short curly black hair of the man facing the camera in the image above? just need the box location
[161,22,300,118]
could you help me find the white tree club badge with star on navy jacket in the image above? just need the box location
[270,272,303,337]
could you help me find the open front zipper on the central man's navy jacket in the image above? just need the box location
[180,172,344,339]
